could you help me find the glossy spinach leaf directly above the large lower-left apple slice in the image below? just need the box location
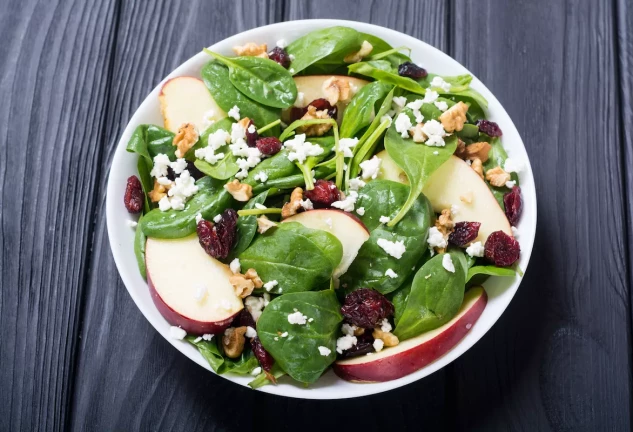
[137,177,232,238]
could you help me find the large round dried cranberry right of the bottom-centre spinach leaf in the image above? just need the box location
[341,288,394,328]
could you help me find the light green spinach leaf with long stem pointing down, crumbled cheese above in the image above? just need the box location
[385,110,457,226]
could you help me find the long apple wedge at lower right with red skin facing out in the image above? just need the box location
[333,287,488,382]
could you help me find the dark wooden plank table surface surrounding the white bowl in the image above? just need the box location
[0,0,633,431]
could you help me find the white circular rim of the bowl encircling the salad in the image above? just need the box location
[106,19,537,399]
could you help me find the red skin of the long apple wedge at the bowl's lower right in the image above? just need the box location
[332,288,488,383]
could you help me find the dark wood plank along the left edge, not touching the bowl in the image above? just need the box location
[0,0,117,431]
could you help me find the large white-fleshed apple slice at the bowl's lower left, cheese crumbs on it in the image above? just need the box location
[145,235,244,334]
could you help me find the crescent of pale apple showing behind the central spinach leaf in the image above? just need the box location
[284,209,369,279]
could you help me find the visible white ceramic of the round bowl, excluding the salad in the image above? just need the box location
[106,20,536,399]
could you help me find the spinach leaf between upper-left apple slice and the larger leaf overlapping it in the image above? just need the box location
[200,61,278,131]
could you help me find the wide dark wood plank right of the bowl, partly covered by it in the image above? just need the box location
[452,0,631,431]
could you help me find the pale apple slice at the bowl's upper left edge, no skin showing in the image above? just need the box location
[158,76,226,133]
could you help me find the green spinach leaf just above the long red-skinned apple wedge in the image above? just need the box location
[394,250,466,340]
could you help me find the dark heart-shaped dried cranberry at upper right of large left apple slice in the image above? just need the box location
[196,209,237,259]
